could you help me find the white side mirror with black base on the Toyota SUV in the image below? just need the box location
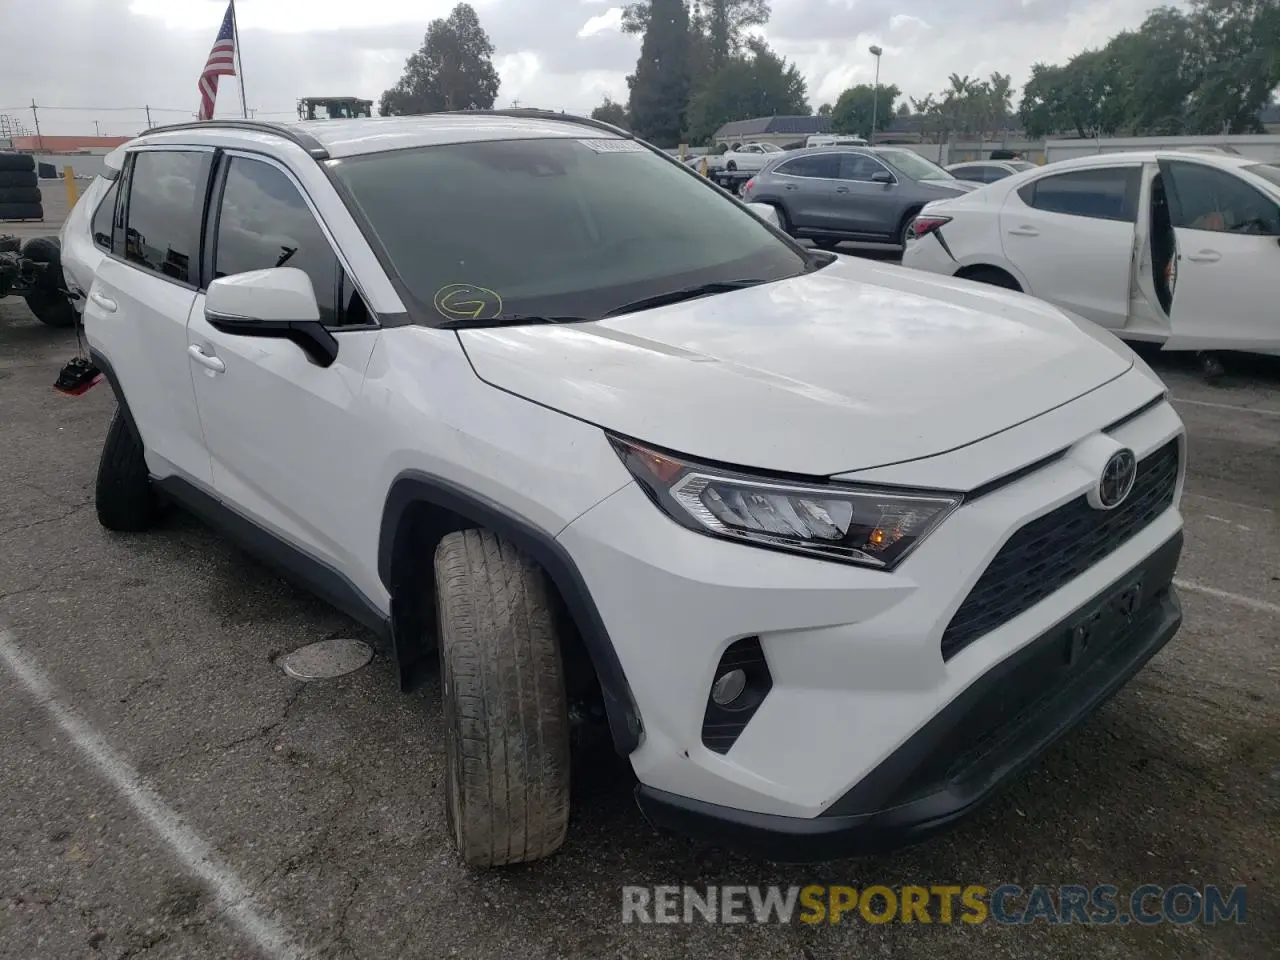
[205,266,338,366]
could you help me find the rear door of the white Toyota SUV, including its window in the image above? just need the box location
[84,146,214,486]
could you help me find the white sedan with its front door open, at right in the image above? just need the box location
[902,151,1280,355]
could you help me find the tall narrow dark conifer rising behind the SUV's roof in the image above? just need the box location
[627,0,690,147]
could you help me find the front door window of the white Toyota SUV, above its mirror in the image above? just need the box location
[214,156,342,326]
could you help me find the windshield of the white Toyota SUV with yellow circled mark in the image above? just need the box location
[330,137,809,323]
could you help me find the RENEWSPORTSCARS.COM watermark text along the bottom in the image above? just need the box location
[622,883,1245,925]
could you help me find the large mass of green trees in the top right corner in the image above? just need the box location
[1019,0,1280,137]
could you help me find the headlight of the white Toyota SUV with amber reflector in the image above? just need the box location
[609,436,961,570]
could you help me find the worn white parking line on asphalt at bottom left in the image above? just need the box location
[0,628,307,960]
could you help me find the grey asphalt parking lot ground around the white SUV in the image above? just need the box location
[0,203,1280,960]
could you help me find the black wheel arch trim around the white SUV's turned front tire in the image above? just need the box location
[378,470,643,756]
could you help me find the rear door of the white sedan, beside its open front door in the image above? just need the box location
[1000,163,1142,329]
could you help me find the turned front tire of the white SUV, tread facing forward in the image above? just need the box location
[435,530,570,867]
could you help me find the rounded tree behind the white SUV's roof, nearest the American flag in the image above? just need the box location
[379,4,500,116]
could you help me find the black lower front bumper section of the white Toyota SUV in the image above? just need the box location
[636,532,1183,863]
